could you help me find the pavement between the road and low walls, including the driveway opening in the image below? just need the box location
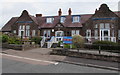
[2,48,120,70]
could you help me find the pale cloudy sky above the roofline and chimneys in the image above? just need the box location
[0,0,120,29]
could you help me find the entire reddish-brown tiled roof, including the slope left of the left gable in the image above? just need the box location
[2,11,120,31]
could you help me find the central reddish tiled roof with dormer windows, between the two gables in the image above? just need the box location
[36,14,92,28]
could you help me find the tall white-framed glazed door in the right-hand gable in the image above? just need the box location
[100,29,110,41]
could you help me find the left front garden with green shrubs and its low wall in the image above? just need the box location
[1,34,42,50]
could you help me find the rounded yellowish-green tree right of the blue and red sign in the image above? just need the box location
[72,35,85,51]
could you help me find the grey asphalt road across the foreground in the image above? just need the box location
[1,55,118,73]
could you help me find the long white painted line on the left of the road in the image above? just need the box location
[0,53,58,65]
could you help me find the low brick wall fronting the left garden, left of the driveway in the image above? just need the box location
[2,43,39,50]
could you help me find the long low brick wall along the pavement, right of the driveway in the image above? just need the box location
[50,49,120,62]
